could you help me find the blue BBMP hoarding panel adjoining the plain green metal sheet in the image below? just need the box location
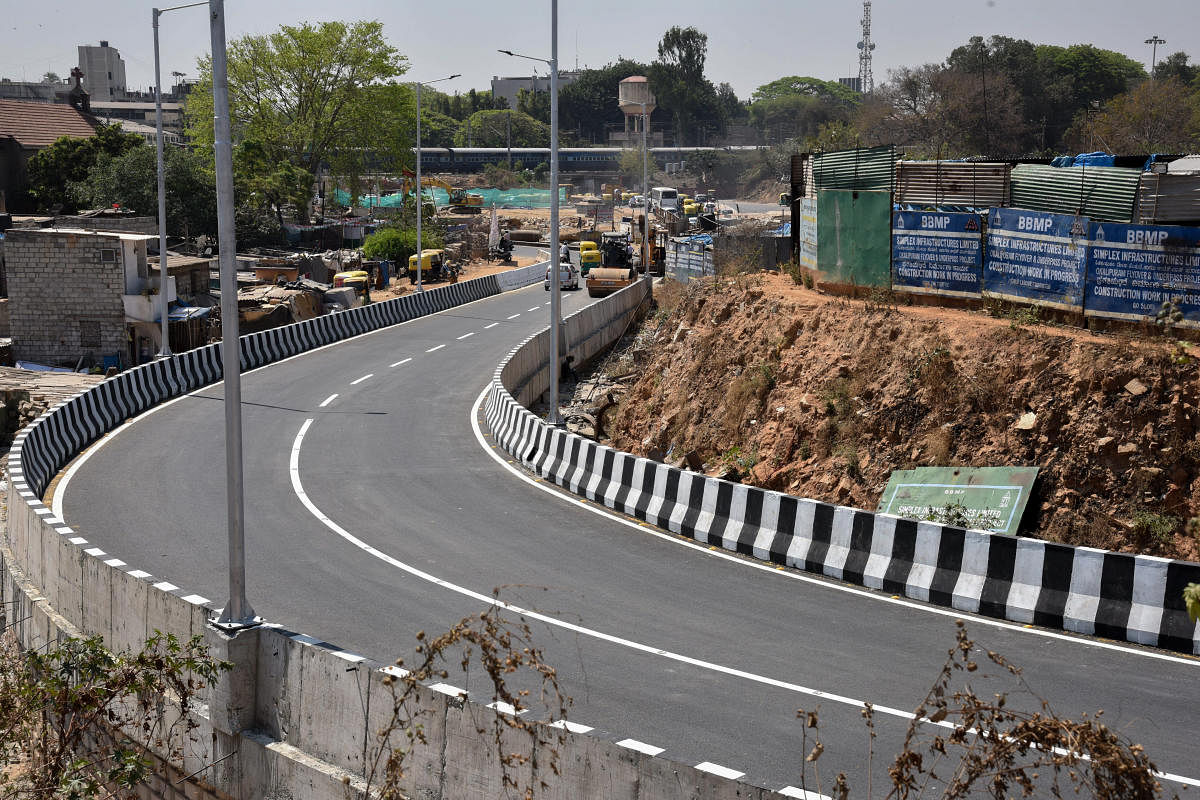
[892,211,983,297]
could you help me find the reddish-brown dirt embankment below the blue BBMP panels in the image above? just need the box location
[604,275,1200,560]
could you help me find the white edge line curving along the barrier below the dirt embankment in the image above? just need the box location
[470,386,1200,667]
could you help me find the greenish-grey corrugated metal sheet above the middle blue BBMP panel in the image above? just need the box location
[1012,164,1142,223]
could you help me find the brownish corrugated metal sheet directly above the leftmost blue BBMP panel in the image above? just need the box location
[896,161,1013,207]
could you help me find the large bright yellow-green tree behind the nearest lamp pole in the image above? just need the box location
[186,22,407,217]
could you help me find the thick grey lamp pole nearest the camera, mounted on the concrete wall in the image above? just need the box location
[209,0,257,627]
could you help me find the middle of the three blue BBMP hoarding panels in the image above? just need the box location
[983,209,1090,311]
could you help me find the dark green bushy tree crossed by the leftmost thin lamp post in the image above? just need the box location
[71,148,217,239]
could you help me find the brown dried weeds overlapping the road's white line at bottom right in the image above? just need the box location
[797,620,1177,800]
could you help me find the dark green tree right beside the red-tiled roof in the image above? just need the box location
[26,124,141,211]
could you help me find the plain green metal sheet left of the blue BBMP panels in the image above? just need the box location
[817,190,892,287]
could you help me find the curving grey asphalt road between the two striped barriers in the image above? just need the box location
[61,271,1200,796]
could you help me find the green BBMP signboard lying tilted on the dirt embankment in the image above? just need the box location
[880,467,1038,534]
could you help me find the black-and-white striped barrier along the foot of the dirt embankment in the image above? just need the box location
[486,284,1200,654]
